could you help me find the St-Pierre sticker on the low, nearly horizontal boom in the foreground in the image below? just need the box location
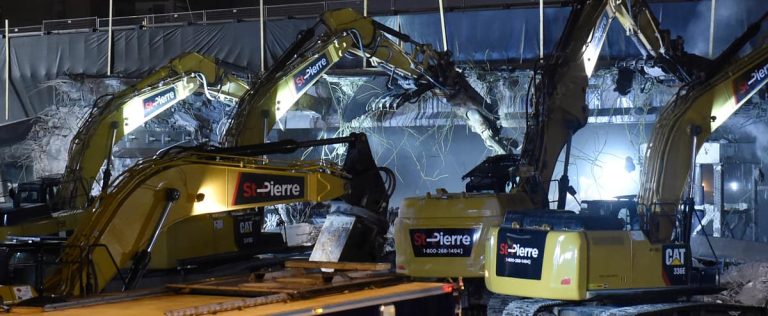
[232,172,304,205]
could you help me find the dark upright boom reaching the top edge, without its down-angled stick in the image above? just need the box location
[516,1,609,208]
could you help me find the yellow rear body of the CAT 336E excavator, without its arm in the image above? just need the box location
[485,211,711,301]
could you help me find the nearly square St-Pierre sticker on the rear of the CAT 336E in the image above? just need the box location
[496,228,548,280]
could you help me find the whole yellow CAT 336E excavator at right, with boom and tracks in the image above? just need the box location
[485,9,768,315]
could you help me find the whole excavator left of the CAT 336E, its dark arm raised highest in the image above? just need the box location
[395,0,693,278]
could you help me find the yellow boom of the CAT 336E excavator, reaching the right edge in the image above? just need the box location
[638,14,768,242]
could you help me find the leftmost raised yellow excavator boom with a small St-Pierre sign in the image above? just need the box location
[56,53,248,209]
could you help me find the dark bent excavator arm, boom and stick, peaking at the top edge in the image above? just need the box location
[518,0,690,208]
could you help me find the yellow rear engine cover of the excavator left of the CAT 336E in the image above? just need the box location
[395,193,530,277]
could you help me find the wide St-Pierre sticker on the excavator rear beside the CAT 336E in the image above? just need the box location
[410,228,478,257]
